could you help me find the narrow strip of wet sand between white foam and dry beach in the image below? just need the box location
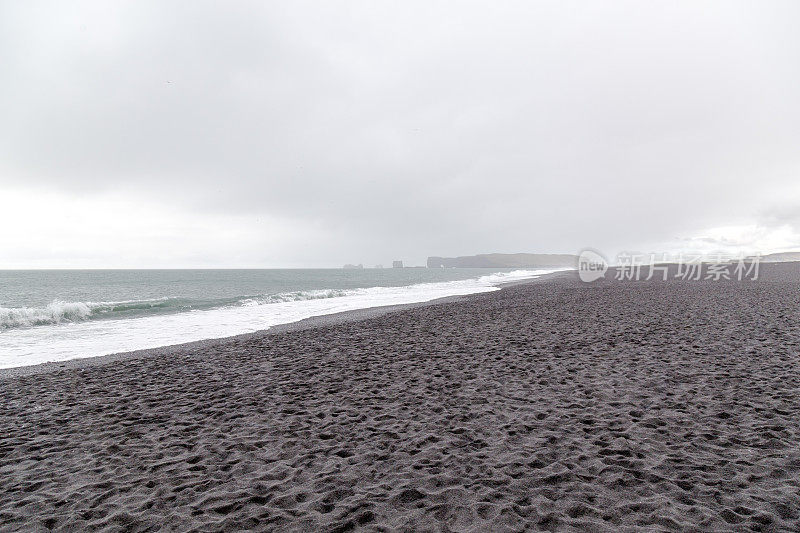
[0,270,572,381]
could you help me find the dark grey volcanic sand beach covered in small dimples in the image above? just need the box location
[0,265,800,531]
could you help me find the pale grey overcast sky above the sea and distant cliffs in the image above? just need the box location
[0,0,800,268]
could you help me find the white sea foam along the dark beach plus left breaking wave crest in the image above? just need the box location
[0,270,552,368]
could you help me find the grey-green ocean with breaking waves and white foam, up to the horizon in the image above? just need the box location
[0,268,551,368]
